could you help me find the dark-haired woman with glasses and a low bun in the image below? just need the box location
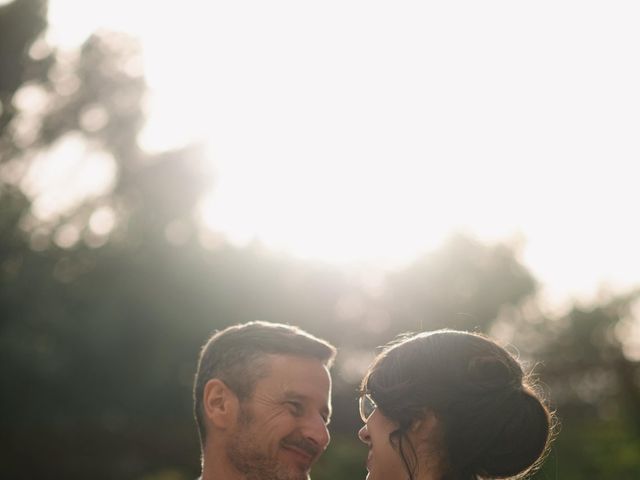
[358,330,553,480]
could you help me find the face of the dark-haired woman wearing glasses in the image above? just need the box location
[358,408,408,480]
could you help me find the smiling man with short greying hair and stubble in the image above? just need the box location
[194,322,336,480]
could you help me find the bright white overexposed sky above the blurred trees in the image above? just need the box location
[45,0,640,308]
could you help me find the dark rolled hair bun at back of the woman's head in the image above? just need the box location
[478,390,551,478]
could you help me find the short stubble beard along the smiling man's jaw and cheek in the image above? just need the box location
[226,407,309,480]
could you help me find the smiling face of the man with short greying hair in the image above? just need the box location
[226,355,331,480]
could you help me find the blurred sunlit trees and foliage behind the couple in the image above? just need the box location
[0,0,640,480]
